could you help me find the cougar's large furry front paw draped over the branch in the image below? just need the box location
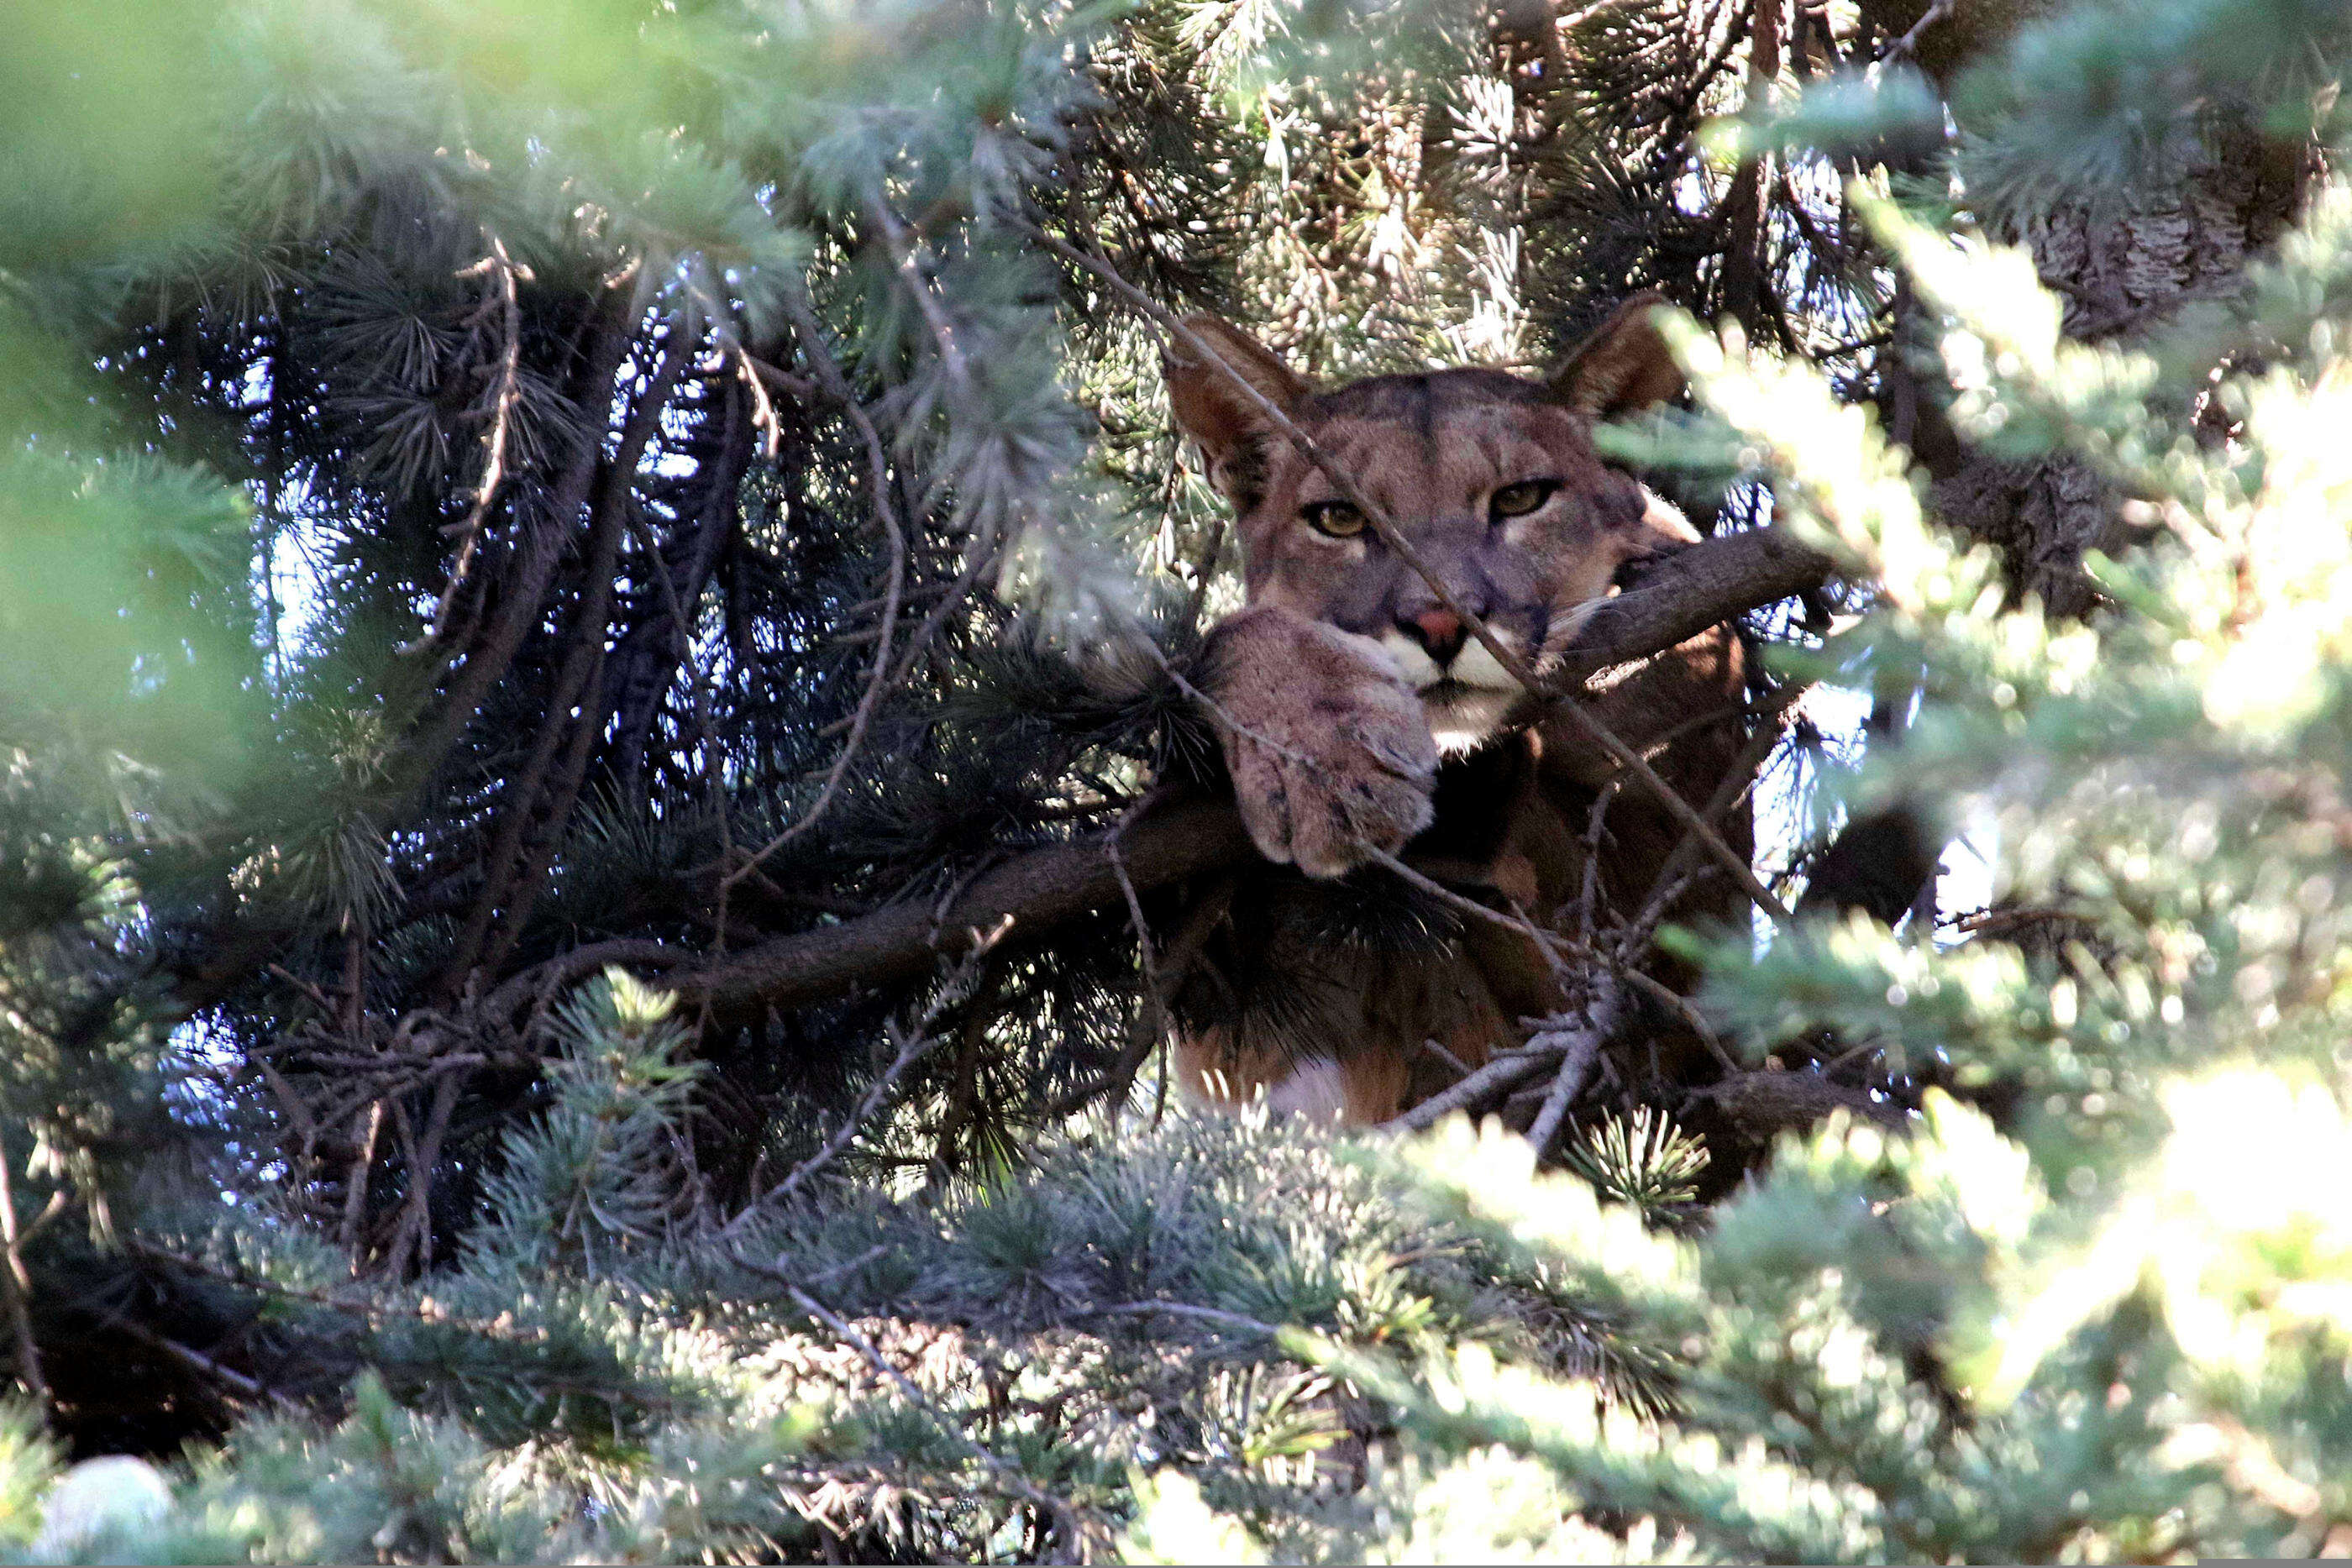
[1214,609,1437,877]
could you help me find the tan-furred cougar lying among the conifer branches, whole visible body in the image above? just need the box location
[1167,298,1747,1124]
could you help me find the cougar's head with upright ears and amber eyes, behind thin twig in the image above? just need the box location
[1162,294,1696,750]
